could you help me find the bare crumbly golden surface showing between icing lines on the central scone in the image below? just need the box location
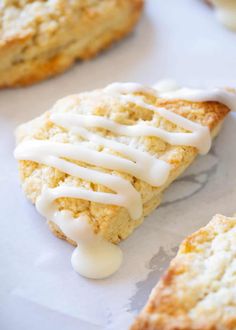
[17,90,229,243]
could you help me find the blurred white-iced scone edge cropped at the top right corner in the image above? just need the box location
[211,0,236,31]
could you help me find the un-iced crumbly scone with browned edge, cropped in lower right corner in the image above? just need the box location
[131,215,236,330]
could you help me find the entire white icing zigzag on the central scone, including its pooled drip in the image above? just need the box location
[15,83,236,278]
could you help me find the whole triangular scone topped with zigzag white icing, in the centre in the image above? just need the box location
[15,83,236,278]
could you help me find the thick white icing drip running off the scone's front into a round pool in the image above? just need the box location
[36,188,122,279]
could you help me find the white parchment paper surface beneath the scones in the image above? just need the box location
[0,0,236,330]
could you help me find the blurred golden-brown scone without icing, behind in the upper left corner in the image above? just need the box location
[0,0,143,88]
